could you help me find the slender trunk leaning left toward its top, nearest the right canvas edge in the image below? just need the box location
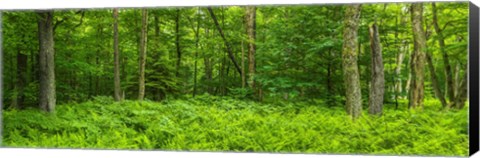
[432,3,455,100]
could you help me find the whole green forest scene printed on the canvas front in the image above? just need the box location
[2,2,468,156]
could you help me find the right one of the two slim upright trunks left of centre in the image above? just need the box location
[138,9,148,101]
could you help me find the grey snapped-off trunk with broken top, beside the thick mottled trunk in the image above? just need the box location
[368,24,385,114]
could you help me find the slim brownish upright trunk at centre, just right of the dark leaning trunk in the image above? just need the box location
[246,6,257,90]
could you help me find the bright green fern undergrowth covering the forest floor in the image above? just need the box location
[3,96,468,156]
